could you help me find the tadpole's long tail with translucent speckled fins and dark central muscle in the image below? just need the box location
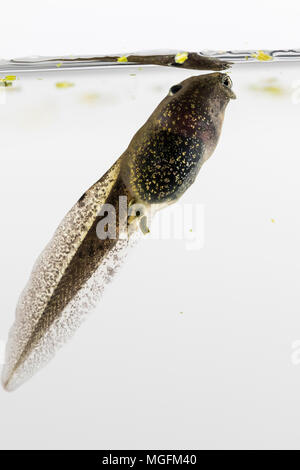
[2,159,139,391]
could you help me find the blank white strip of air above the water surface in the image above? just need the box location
[0,0,300,58]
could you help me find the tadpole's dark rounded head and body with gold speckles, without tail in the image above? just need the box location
[121,73,235,205]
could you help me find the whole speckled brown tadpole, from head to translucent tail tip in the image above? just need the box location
[2,73,234,390]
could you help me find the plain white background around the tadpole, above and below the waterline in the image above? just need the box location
[0,1,300,449]
